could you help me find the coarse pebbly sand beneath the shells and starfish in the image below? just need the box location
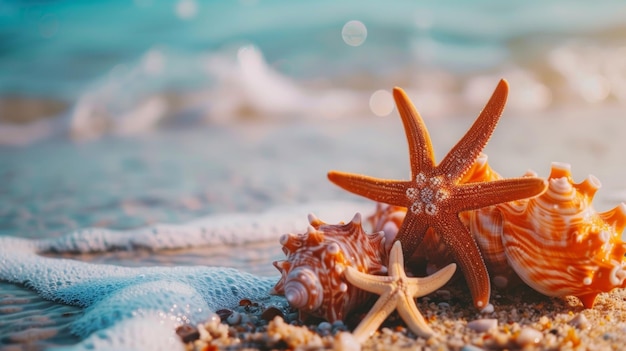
[173,283,626,351]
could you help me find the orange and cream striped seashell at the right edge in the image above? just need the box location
[498,163,626,308]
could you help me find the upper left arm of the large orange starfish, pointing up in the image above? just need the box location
[393,87,435,178]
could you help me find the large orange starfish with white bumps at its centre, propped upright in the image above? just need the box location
[328,80,546,310]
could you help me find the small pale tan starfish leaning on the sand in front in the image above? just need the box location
[344,241,456,343]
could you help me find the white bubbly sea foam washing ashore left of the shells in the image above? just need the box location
[0,202,371,350]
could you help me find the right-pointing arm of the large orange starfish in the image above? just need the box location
[454,177,548,212]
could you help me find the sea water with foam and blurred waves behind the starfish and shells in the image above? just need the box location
[0,0,626,350]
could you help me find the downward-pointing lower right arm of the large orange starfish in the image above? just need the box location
[436,217,491,310]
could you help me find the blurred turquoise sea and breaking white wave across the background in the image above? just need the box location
[0,0,626,145]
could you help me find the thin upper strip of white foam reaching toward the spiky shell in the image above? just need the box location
[38,201,373,253]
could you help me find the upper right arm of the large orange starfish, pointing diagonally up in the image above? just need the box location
[438,79,509,179]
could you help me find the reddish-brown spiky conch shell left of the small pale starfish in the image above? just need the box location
[270,213,387,322]
